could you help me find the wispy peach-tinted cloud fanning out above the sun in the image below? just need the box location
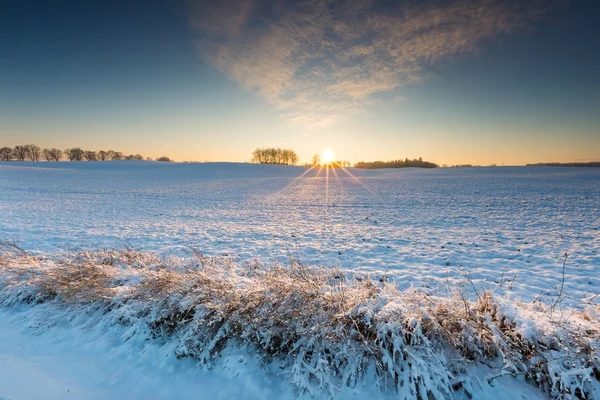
[191,0,543,126]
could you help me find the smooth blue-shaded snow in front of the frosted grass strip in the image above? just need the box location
[0,309,546,400]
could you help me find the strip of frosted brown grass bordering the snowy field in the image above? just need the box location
[0,242,600,399]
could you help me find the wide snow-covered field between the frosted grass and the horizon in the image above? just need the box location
[0,162,600,301]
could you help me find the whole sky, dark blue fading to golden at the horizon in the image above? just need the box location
[0,0,600,165]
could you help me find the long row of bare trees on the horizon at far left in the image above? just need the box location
[0,144,171,162]
